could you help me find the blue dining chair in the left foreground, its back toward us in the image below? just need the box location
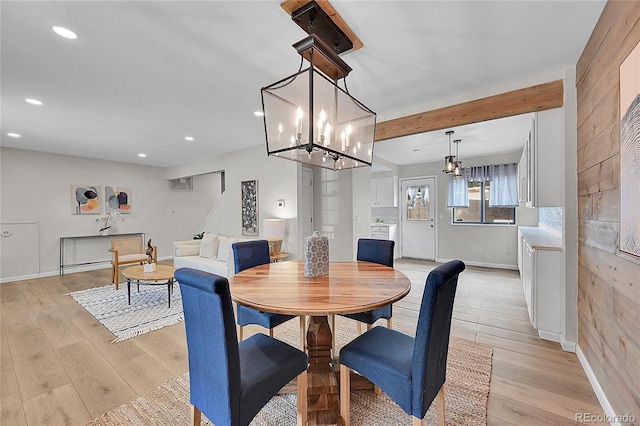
[175,268,308,426]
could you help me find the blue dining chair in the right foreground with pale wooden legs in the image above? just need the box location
[340,260,465,425]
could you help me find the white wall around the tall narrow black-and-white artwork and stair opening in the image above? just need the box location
[165,145,301,259]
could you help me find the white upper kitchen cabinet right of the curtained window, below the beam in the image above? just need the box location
[518,108,564,207]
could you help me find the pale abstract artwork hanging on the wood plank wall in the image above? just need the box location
[619,43,640,257]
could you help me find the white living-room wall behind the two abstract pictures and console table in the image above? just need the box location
[0,148,220,281]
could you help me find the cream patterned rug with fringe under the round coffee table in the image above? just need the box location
[69,283,184,343]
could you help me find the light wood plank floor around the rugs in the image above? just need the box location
[0,260,602,426]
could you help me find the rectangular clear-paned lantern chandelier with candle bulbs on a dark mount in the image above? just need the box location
[261,1,376,170]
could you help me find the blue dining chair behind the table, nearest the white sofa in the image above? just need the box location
[231,240,302,341]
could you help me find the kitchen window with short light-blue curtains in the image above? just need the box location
[448,163,518,224]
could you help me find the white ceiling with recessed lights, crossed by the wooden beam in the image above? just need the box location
[0,0,605,167]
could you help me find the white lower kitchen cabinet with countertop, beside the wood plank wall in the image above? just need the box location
[518,226,565,342]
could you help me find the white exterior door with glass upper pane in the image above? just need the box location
[400,177,437,260]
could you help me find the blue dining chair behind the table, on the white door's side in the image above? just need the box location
[342,238,395,334]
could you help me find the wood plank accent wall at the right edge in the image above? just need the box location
[576,0,640,424]
